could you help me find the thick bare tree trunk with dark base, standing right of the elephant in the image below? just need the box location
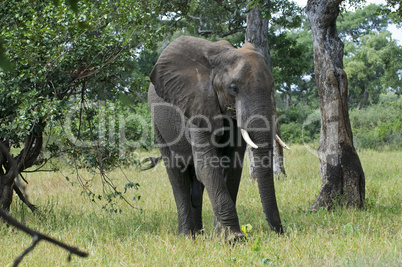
[306,0,365,211]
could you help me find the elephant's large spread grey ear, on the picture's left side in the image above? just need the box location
[150,36,233,131]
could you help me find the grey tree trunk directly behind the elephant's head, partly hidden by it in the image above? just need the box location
[246,0,286,179]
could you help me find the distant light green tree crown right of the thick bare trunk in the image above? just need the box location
[345,31,402,106]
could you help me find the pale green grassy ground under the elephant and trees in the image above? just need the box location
[0,145,402,266]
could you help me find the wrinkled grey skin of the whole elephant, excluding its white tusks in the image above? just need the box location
[148,37,283,237]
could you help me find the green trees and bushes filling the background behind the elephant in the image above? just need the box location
[0,0,402,213]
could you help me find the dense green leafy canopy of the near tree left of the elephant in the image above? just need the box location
[0,0,163,211]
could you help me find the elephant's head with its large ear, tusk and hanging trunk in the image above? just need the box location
[150,37,282,232]
